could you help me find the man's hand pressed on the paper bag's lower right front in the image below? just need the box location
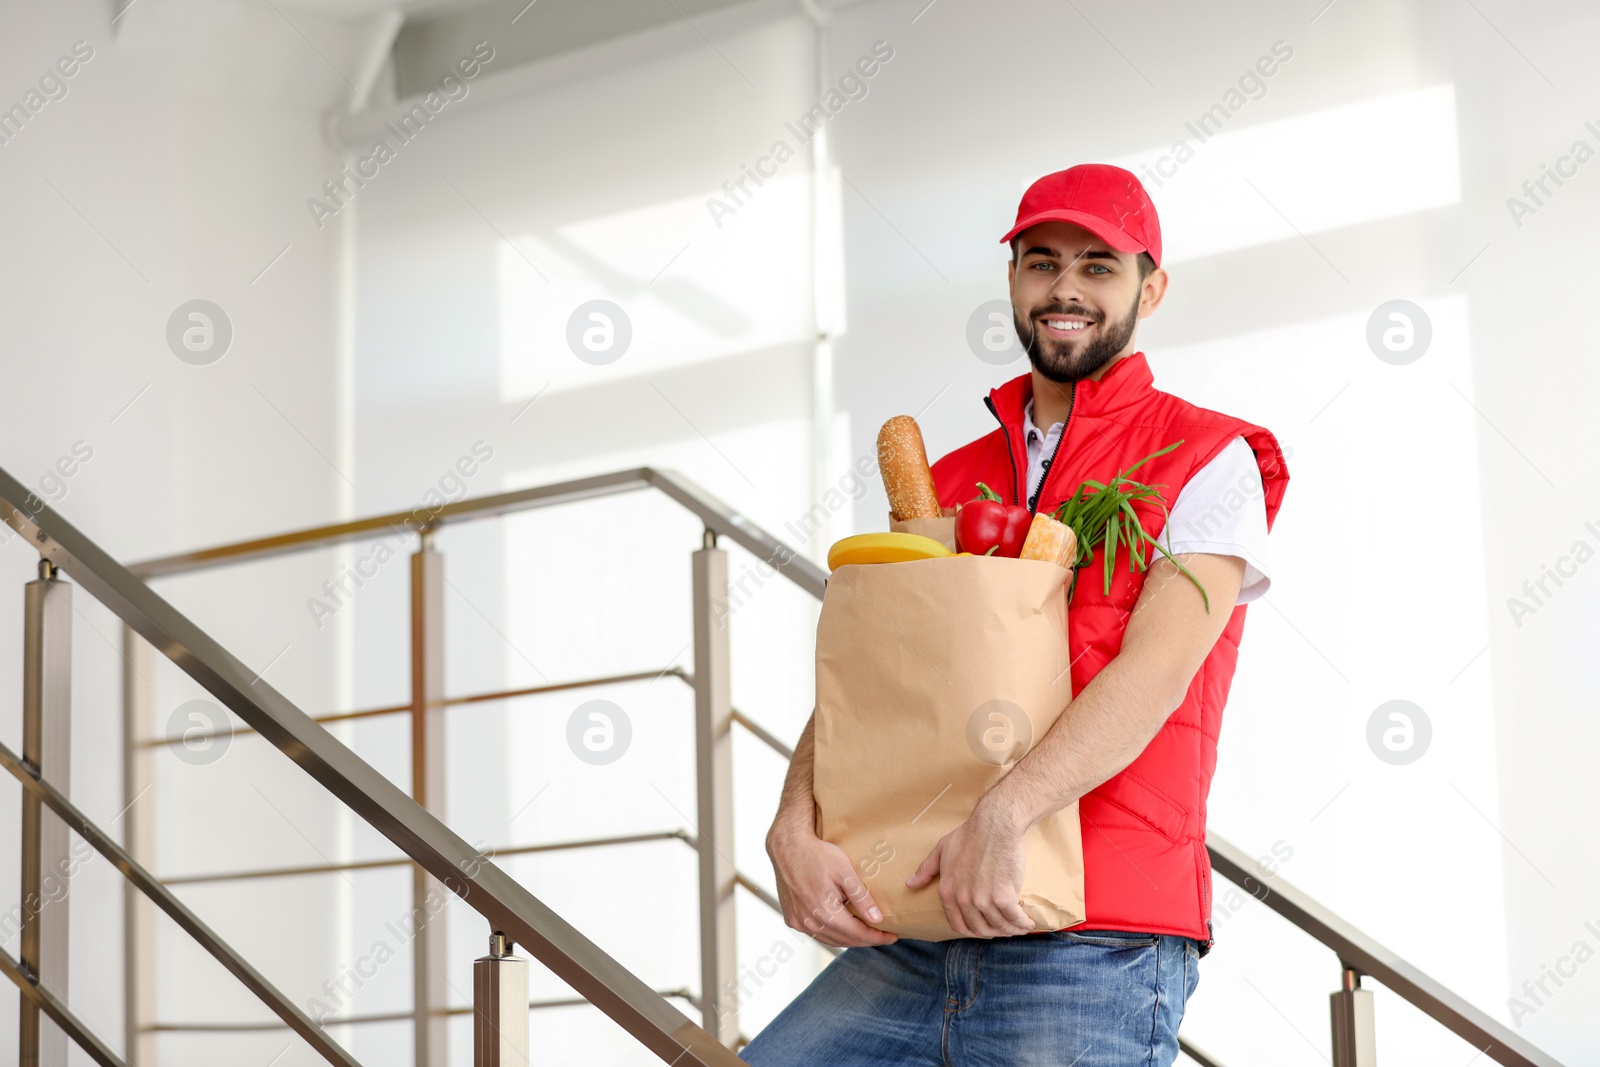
[906,803,1034,937]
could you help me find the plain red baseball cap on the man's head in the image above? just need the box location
[1000,163,1162,267]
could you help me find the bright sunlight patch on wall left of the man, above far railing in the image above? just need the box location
[499,174,811,402]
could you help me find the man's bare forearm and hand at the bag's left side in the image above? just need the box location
[766,713,896,949]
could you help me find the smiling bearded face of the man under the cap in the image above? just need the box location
[1011,222,1165,382]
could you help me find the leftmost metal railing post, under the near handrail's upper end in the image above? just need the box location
[18,560,72,1067]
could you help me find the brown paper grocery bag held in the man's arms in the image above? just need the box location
[813,557,1083,941]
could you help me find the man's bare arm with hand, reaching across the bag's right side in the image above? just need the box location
[907,553,1245,937]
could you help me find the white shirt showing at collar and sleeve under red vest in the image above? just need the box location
[1022,400,1272,603]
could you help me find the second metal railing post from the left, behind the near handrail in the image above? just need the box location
[121,622,157,1067]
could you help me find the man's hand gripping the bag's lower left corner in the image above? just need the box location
[766,829,898,949]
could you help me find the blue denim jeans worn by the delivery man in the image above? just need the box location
[741,929,1200,1067]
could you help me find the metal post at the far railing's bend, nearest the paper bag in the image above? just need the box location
[693,530,739,1048]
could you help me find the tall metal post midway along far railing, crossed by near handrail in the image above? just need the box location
[411,530,451,1067]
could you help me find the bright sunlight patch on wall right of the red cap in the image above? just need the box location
[1094,85,1461,264]
